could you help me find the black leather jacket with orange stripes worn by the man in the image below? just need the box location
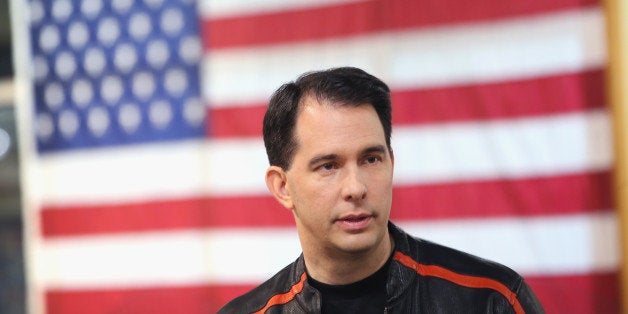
[219,223,544,313]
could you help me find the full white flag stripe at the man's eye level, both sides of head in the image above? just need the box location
[33,111,612,204]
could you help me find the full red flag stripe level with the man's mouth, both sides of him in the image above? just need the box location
[40,172,612,237]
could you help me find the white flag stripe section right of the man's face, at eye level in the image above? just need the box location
[392,111,613,184]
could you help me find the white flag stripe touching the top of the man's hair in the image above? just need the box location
[202,8,606,106]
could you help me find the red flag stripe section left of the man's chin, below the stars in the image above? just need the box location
[41,195,293,237]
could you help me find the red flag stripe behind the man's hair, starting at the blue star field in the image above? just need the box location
[208,69,606,137]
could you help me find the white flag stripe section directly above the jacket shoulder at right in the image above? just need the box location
[400,211,619,275]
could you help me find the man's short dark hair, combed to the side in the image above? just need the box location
[263,67,392,170]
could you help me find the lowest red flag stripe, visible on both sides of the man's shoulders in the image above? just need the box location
[46,272,619,314]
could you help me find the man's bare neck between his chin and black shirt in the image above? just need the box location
[303,235,394,285]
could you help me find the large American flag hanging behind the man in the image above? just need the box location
[13,0,620,314]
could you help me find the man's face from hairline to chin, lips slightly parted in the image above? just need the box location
[284,97,393,254]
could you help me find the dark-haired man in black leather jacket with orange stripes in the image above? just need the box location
[221,68,543,313]
